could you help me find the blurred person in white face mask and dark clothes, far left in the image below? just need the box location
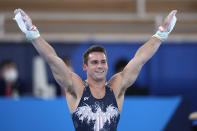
[0,60,25,97]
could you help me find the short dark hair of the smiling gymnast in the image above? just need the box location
[83,45,107,65]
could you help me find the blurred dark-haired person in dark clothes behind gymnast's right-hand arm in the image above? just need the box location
[115,58,148,95]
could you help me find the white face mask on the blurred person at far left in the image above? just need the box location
[4,68,18,83]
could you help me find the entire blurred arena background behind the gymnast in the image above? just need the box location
[0,0,197,131]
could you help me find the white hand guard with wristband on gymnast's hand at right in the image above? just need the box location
[153,13,177,41]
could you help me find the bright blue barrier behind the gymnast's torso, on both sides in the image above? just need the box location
[0,96,182,131]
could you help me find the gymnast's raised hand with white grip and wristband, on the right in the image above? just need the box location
[153,10,177,41]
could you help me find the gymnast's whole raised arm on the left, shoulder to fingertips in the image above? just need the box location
[14,9,80,96]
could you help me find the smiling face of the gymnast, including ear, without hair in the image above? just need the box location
[83,52,108,81]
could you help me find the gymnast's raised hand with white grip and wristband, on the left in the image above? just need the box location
[14,9,40,40]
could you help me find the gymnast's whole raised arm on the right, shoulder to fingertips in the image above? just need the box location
[109,10,177,96]
